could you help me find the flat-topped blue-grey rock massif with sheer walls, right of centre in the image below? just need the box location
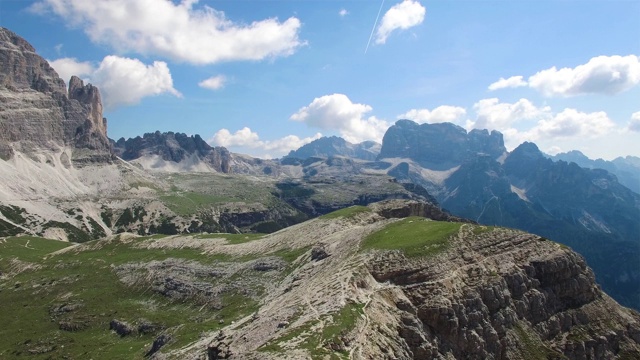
[378,120,506,170]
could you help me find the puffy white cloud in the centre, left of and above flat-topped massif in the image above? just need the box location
[291,94,390,143]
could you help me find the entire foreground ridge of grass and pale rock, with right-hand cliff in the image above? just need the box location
[0,200,640,359]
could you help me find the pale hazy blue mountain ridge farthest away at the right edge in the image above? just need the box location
[549,150,640,194]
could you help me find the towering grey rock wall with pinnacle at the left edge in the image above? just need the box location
[0,28,112,163]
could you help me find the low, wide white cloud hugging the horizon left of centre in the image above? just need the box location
[209,127,322,157]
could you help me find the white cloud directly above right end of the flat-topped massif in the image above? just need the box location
[472,98,551,132]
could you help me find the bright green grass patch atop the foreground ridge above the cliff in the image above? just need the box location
[360,217,462,257]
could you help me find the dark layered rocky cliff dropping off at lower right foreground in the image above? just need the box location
[369,228,640,359]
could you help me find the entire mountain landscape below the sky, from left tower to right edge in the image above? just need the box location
[0,28,640,359]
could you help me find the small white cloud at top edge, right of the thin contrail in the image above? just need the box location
[376,0,426,44]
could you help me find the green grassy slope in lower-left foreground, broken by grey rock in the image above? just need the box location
[0,234,298,359]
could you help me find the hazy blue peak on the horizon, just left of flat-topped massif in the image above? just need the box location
[285,136,380,160]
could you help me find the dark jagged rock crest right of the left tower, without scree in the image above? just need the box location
[114,131,231,173]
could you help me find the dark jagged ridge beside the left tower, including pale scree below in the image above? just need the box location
[113,131,231,173]
